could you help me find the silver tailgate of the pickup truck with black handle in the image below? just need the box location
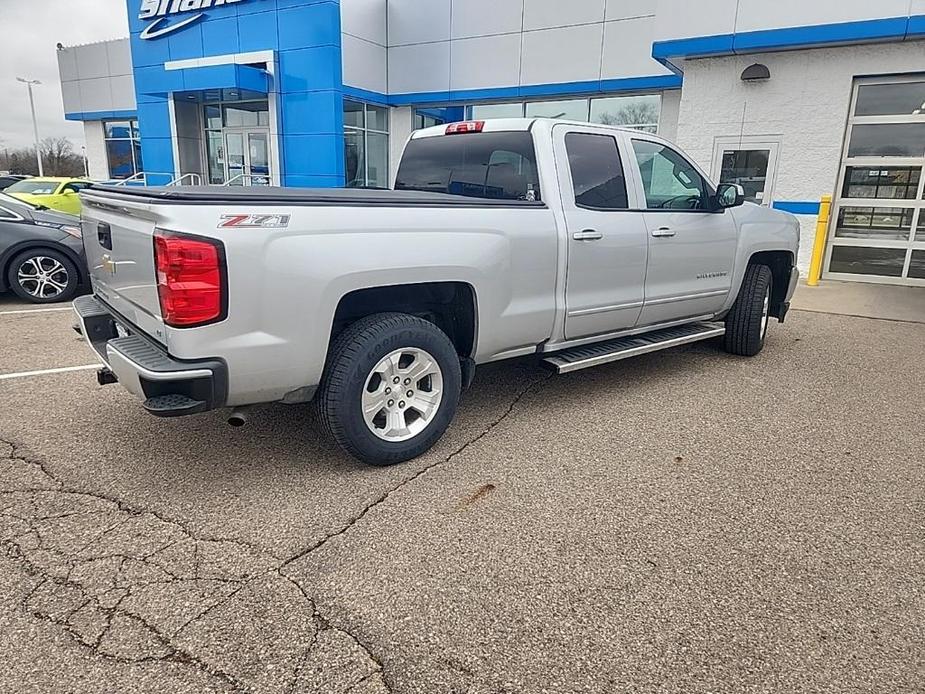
[81,191,166,343]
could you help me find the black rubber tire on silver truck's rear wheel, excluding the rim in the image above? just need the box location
[318,313,462,466]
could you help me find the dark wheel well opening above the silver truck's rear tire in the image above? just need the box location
[328,281,478,359]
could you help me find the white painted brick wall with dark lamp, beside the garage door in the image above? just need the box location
[677,41,925,201]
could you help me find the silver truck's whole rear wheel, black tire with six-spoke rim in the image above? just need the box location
[319,313,462,465]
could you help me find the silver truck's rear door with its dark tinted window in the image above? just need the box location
[553,125,648,340]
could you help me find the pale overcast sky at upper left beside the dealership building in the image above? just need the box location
[0,0,128,151]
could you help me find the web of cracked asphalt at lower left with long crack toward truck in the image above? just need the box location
[0,375,551,694]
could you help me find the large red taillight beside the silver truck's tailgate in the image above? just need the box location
[154,229,226,328]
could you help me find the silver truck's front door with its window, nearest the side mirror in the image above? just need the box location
[632,137,738,325]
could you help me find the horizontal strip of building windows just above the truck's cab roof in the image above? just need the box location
[468,94,662,133]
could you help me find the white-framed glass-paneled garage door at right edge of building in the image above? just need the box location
[825,75,925,285]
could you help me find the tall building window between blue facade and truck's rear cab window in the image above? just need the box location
[344,99,389,188]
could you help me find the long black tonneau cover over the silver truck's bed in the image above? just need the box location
[85,184,545,208]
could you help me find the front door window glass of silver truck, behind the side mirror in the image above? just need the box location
[633,140,708,210]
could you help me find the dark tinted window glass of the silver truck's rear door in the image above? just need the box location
[565,133,629,210]
